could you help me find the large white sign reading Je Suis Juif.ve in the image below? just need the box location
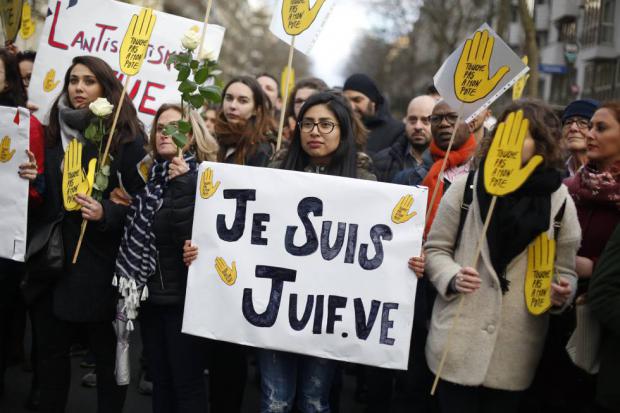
[183,162,427,369]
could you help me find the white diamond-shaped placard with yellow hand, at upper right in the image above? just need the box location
[433,23,529,122]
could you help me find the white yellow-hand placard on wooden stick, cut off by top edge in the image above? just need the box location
[269,0,335,150]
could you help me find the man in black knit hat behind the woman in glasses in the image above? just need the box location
[342,73,405,155]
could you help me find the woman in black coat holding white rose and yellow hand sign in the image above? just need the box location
[27,56,146,413]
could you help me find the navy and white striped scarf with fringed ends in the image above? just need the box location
[112,153,196,330]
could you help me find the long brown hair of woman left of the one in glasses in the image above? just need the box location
[215,76,275,165]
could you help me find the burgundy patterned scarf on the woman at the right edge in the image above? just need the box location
[564,161,620,211]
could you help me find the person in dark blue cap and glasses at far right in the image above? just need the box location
[562,99,600,177]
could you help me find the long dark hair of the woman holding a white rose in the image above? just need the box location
[45,56,146,152]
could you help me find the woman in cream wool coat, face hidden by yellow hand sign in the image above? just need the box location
[426,101,581,413]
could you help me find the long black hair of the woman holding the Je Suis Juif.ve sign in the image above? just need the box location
[281,92,357,178]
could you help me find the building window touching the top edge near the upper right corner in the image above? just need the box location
[581,0,615,46]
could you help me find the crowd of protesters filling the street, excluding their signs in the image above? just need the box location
[0,41,620,413]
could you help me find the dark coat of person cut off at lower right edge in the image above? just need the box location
[588,225,620,412]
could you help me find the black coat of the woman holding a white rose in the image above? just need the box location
[38,136,146,322]
